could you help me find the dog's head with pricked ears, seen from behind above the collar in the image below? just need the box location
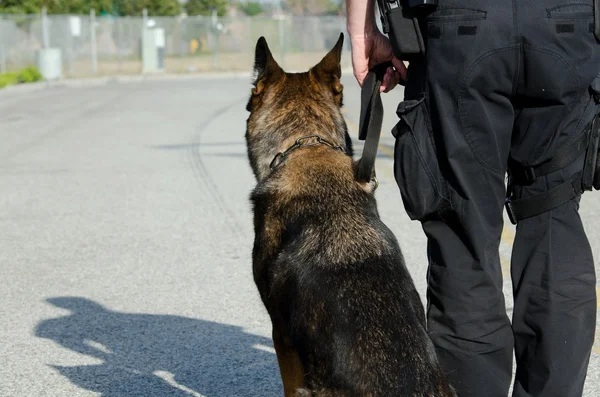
[246,34,352,181]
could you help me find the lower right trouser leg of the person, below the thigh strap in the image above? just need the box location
[511,188,596,397]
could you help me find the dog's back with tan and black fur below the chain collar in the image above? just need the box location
[253,149,447,396]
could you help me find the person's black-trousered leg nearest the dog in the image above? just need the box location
[396,0,518,397]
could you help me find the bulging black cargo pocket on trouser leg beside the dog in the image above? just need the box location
[392,99,450,221]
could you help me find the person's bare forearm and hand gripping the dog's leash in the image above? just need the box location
[346,0,406,92]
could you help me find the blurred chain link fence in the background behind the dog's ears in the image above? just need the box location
[0,15,350,77]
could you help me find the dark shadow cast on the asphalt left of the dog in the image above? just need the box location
[35,297,282,397]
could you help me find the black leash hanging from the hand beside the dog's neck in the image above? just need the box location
[357,62,392,182]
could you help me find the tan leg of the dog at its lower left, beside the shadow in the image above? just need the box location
[273,327,304,397]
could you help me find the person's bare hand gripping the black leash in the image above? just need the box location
[350,30,406,92]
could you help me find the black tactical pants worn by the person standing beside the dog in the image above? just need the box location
[393,0,600,397]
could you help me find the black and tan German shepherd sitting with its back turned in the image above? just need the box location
[246,34,455,397]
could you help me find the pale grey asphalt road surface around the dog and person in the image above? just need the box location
[0,77,600,397]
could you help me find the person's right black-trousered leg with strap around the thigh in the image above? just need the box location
[511,0,600,397]
